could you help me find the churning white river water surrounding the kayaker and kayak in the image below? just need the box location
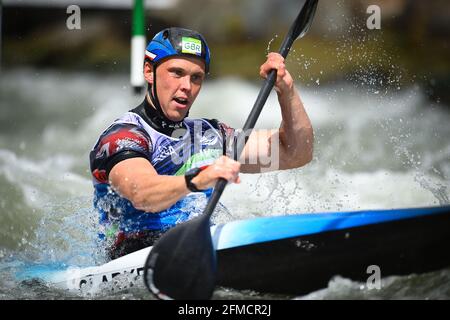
[0,69,450,299]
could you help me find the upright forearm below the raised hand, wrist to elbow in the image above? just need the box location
[278,88,314,169]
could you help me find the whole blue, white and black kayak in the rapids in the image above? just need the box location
[22,206,450,294]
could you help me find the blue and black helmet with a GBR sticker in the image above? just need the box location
[145,28,210,73]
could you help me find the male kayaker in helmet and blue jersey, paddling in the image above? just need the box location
[90,28,313,259]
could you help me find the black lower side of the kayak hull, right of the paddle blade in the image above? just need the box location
[217,207,450,294]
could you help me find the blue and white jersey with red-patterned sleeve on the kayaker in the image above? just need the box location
[90,103,234,239]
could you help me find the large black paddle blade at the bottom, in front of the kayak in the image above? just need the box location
[144,216,217,300]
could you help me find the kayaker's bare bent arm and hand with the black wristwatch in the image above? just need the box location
[109,156,240,213]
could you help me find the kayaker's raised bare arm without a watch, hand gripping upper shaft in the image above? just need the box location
[239,52,314,173]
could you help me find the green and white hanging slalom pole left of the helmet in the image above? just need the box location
[130,0,146,93]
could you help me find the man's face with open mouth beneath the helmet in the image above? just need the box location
[144,57,205,121]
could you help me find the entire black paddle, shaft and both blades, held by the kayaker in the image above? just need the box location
[144,0,318,299]
